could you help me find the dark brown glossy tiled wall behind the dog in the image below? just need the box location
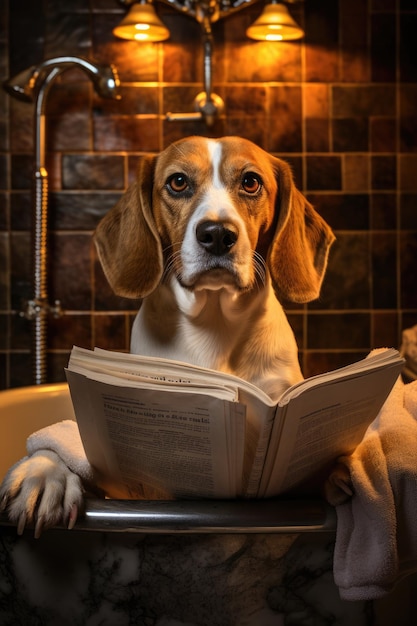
[0,0,417,388]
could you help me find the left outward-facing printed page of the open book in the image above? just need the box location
[67,370,245,499]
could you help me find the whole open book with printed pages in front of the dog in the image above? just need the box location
[66,347,403,498]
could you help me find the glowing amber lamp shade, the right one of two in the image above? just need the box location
[246,3,304,41]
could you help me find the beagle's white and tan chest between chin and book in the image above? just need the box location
[131,272,302,399]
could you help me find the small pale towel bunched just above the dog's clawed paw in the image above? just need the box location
[26,420,95,485]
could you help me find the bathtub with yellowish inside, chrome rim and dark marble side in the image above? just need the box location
[0,384,411,626]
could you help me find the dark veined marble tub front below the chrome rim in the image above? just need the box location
[0,530,373,626]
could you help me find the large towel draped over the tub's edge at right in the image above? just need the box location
[327,379,417,600]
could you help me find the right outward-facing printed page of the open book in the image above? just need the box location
[259,359,402,497]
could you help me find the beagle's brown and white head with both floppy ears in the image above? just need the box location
[95,137,334,302]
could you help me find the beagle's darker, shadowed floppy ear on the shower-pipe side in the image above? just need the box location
[94,155,163,298]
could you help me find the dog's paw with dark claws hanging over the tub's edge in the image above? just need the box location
[0,450,83,537]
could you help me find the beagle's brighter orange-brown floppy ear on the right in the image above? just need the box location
[268,157,335,302]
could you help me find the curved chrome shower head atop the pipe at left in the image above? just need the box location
[3,56,120,102]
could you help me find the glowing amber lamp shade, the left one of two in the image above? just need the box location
[113,3,169,42]
